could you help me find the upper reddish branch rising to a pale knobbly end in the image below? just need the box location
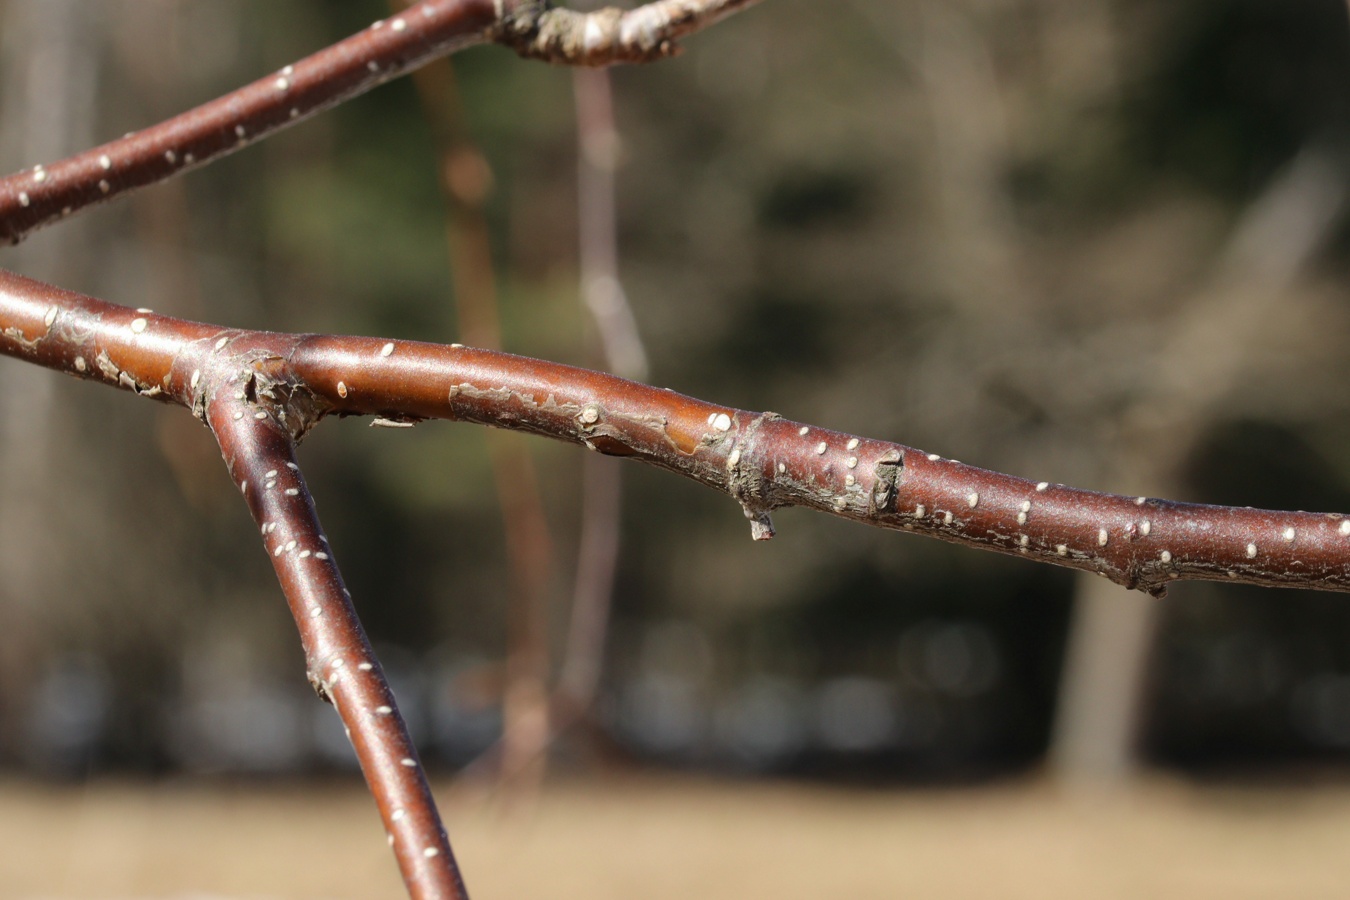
[0,0,759,244]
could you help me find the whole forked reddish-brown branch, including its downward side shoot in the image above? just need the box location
[0,221,1350,896]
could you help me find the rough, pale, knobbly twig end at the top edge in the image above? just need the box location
[494,0,760,66]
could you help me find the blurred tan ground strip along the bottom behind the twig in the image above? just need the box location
[0,777,1350,900]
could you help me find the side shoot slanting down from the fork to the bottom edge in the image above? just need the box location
[198,372,467,899]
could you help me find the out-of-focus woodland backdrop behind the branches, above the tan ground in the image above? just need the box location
[10,0,1350,896]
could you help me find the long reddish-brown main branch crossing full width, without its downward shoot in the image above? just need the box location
[0,273,1350,595]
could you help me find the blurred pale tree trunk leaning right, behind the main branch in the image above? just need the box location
[1050,147,1346,783]
